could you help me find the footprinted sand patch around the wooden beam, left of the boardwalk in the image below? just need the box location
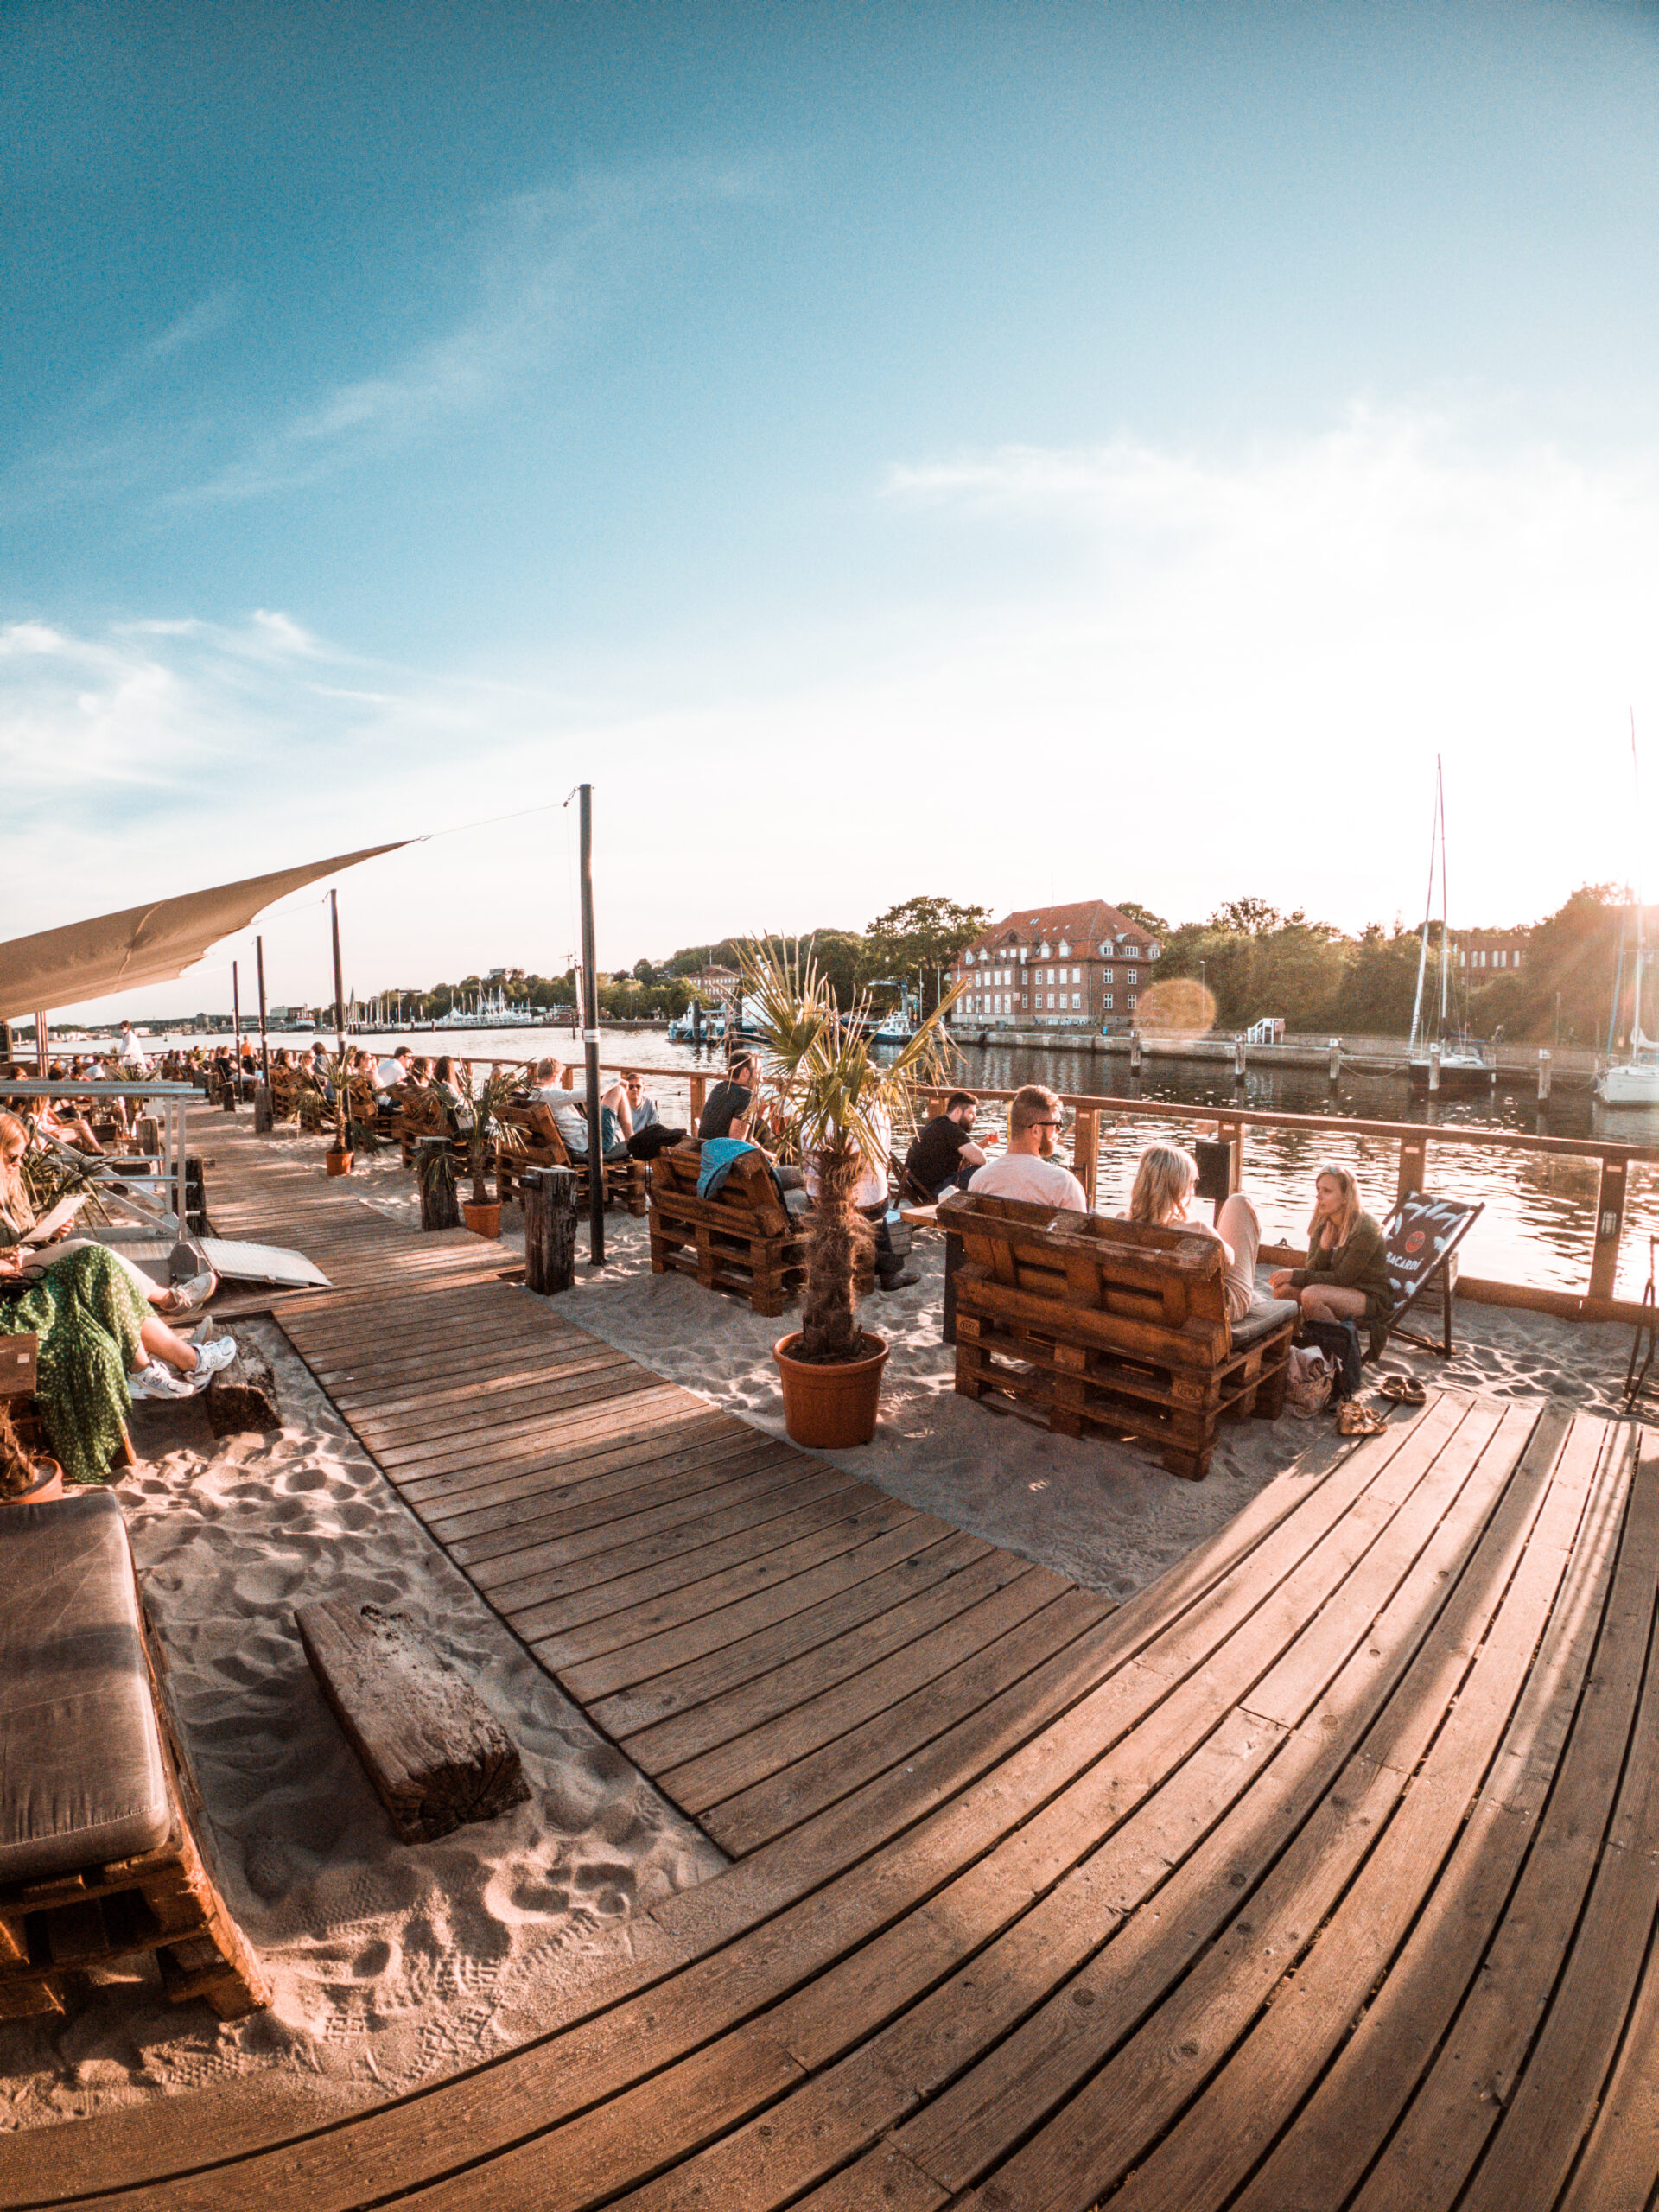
[0,1323,726,2128]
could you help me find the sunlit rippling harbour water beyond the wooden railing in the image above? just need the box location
[179,1028,1659,1299]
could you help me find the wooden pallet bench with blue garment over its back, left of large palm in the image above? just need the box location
[651,1137,827,1314]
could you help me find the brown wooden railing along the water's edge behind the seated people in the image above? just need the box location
[417,1055,1659,1323]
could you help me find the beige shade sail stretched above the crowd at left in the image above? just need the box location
[0,838,411,1022]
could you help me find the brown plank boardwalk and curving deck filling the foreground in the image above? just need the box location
[0,1123,1659,2212]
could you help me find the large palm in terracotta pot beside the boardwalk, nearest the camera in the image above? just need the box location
[739,938,953,1449]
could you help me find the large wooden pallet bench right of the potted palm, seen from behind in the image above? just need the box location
[938,1190,1299,1482]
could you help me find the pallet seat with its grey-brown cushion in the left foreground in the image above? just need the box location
[0,1491,270,2019]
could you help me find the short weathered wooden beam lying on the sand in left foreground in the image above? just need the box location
[294,1597,531,1842]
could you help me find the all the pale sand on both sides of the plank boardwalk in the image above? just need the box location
[0,1154,1628,2128]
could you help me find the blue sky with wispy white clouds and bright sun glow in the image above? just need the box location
[0,0,1659,1018]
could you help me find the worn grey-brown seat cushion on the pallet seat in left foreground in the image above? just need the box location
[0,1491,173,1883]
